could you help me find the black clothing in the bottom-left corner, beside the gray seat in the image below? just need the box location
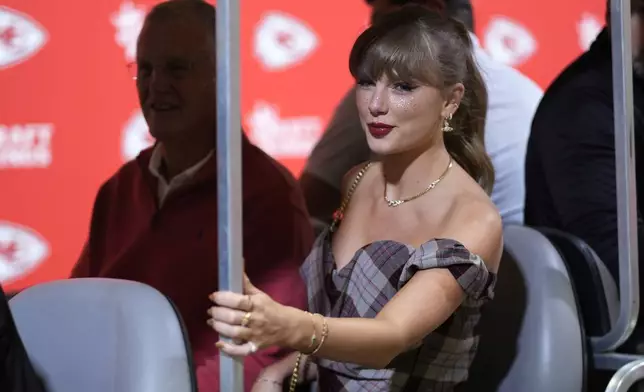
[0,285,47,392]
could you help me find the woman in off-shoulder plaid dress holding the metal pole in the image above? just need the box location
[208,6,503,392]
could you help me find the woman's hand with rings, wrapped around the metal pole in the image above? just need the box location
[208,274,303,356]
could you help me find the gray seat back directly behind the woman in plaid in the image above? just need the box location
[465,226,586,392]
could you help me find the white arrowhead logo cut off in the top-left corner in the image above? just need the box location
[0,6,47,69]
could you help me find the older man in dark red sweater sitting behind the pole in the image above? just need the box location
[72,0,313,392]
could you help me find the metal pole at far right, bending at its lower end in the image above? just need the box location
[593,0,639,352]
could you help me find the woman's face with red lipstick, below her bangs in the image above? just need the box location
[356,76,464,155]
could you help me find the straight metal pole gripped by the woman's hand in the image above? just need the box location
[215,0,244,392]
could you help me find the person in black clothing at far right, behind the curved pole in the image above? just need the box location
[525,0,644,346]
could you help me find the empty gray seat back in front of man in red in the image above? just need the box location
[9,278,196,392]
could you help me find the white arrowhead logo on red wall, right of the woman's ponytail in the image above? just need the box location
[484,16,537,67]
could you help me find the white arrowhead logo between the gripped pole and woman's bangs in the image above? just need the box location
[254,11,319,71]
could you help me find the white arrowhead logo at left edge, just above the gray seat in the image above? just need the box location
[0,221,50,283]
